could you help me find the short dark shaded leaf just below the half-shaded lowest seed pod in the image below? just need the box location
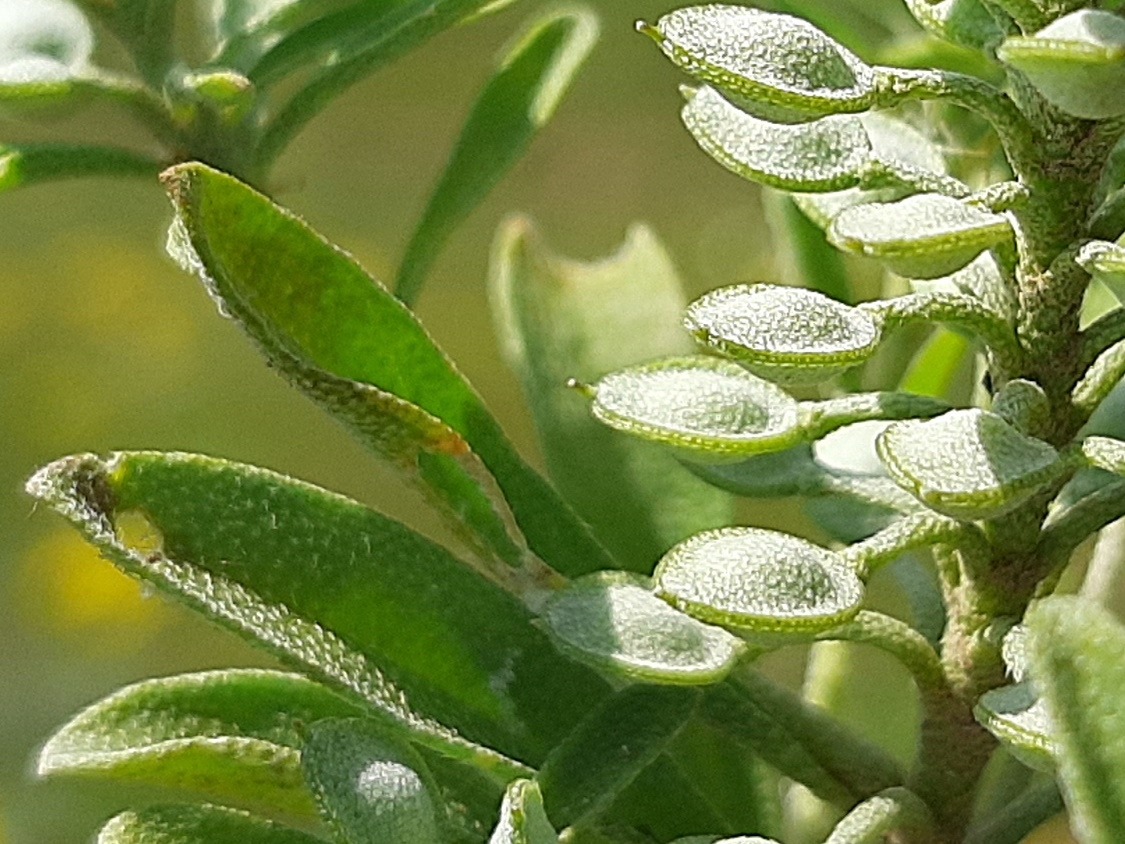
[537,684,700,826]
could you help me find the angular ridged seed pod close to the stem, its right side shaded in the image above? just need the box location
[875,407,1061,520]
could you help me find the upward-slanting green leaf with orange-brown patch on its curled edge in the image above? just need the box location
[165,164,613,574]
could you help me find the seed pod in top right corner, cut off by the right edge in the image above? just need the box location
[997,9,1125,120]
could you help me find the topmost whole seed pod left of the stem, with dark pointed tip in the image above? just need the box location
[644,5,875,123]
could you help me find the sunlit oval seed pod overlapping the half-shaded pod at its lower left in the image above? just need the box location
[654,528,863,635]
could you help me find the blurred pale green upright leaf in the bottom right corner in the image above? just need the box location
[1026,598,1125,844]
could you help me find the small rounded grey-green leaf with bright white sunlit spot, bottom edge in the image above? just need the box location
[300,718,441,844]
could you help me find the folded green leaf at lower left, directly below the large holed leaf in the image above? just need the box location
[38,670,361,816]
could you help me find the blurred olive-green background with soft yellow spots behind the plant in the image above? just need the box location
[0,0,1071,844]
